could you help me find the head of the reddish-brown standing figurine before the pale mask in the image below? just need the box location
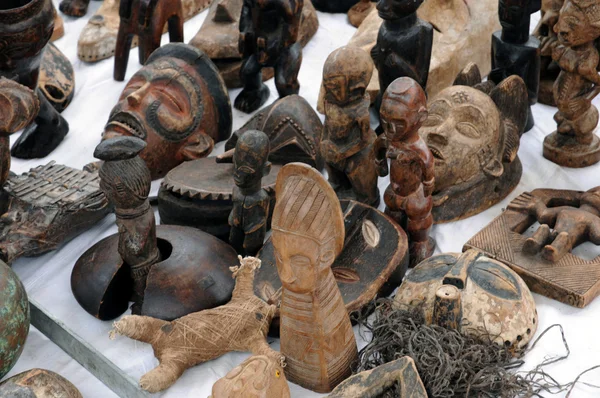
[379,77,427,142]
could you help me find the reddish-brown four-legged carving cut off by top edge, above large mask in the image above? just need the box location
[114,0,183,82]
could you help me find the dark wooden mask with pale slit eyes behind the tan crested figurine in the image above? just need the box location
[254,200,408,336]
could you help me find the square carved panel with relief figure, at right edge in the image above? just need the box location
[465,187,600,308]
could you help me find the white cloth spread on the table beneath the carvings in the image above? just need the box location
[3,0,600,398]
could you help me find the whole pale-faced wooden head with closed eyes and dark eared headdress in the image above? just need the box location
[420,64,528,223]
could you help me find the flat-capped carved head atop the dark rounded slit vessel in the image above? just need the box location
[94,137,151,210]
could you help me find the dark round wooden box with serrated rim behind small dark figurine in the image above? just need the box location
[158,158,281,241]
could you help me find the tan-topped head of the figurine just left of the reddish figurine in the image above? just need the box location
[323,46,373,106]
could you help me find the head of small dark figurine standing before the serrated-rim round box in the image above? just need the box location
[233,130,271,189]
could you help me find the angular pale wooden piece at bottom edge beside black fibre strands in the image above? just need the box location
[328,356,427,398]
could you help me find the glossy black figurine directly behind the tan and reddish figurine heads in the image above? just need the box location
[371,0,433,108]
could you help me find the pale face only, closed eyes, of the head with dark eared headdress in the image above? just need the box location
[419,86,503,192]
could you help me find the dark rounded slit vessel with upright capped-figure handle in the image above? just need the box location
[71,137,236,320]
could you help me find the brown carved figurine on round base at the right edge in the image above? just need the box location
[544,0,600,167]
